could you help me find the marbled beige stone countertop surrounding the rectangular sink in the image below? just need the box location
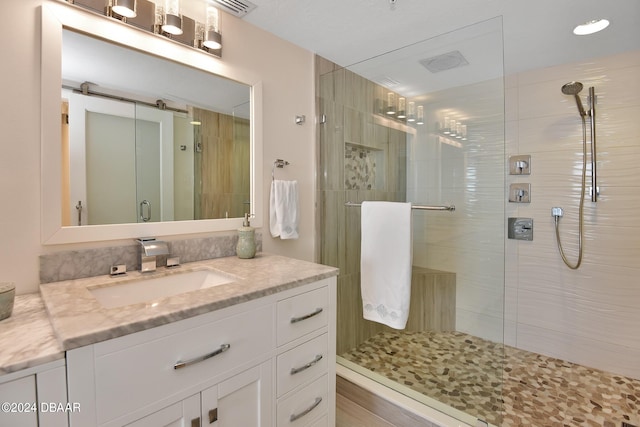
[40,253,338,350]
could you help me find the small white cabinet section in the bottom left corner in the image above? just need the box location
[0,360,68,427]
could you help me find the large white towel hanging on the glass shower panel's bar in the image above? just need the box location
[360,202,412,329]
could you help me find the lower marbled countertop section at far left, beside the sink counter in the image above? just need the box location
[0,293,64,375]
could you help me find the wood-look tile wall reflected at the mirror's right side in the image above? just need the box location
[193,108,250,219]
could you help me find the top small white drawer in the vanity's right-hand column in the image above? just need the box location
[277,286,329,346]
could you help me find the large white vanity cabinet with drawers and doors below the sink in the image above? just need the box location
[67,277,336,427]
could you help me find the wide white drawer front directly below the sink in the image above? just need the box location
[95,305,274,424]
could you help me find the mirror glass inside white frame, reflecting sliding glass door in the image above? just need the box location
[61,30,251,226]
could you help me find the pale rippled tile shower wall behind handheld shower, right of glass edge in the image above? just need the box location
[505,51,640,378]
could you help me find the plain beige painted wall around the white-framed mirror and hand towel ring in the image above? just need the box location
[0,0,315,293]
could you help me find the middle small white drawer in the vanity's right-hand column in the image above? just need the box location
[277,334,328,396]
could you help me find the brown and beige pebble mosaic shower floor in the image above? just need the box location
[341,331,640,427]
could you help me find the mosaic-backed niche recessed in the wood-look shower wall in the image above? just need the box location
[344,143,384,190]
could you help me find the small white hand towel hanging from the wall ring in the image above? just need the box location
[269,179,299,240]
